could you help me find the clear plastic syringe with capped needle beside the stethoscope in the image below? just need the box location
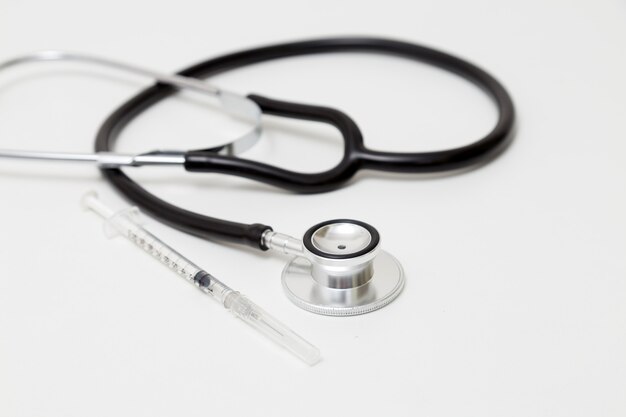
[83,192,321,365]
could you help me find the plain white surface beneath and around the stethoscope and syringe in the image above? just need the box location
[0,0,626,417]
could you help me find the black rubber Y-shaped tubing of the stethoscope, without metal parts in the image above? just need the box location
[95,37,515,250]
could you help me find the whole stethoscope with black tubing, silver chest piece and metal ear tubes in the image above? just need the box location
[0,38,515,316]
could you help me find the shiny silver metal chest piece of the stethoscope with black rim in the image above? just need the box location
[282,219,404,316]
